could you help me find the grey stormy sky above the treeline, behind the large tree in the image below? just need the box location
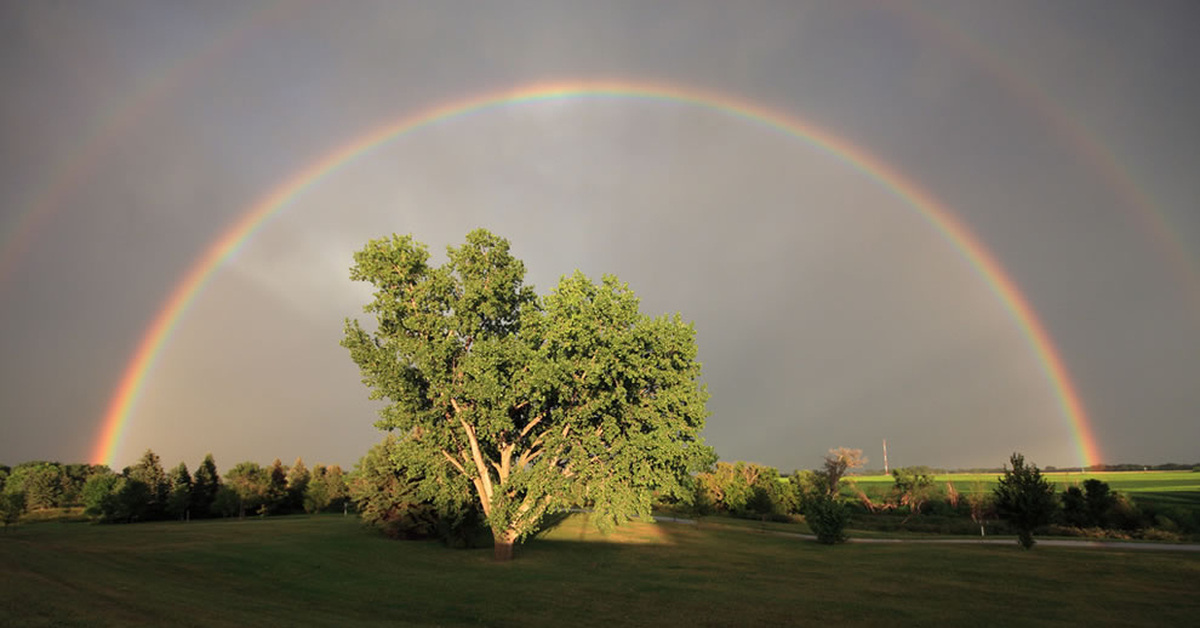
[0,0,1200,471]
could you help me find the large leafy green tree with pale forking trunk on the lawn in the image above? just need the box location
[342,229,712,560]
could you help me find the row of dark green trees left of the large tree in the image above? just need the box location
[0,449,349,525]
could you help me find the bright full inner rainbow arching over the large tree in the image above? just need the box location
[91,80,1100,465]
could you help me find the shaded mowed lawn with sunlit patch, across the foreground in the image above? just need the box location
[0,515,1200,627]
